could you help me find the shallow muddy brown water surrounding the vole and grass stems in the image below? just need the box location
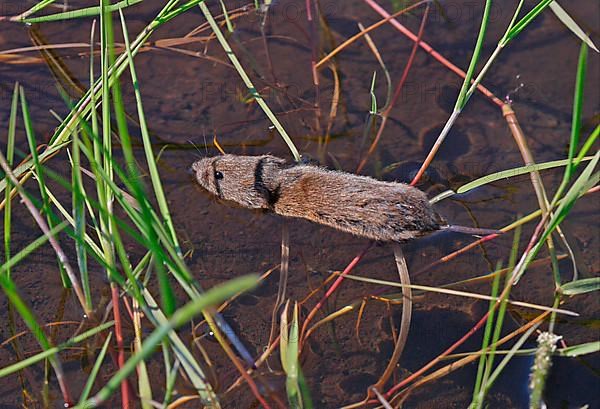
[0,1,600,408]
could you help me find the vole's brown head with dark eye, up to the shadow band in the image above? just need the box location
[192,155,285,209]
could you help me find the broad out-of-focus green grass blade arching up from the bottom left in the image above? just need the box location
[83,275,259,408]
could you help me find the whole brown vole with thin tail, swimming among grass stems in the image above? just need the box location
[192,155,497,242]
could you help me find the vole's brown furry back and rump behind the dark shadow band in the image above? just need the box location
[273,165,443,241]
